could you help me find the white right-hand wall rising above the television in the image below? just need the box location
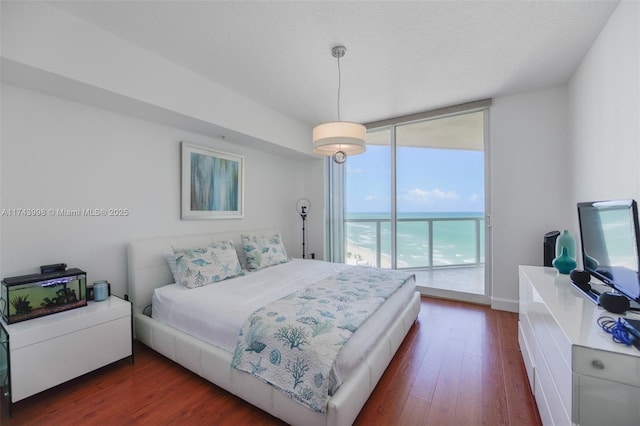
[568,1,640,211]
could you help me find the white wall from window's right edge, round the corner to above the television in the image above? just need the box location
[490,1,640,311]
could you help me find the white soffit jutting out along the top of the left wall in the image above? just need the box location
[0,2,311,158]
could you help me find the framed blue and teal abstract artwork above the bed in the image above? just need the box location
[182,142,244,219]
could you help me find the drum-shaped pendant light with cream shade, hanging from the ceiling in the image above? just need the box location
[313,46,367,164]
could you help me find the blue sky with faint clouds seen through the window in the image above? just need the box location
[345,145,484,213]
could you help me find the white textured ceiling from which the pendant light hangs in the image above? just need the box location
[52,0,618,126]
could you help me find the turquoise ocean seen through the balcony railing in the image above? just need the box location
[345,212,484,268]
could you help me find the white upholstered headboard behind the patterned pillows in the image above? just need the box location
[127,229,277,315]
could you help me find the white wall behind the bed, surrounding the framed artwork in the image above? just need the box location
[0,85,322,295]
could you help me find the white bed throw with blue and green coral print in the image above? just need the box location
[232,267,412,412]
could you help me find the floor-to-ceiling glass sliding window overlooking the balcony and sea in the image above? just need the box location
[344,101,489,302]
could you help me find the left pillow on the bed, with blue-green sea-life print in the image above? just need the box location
[173,241,244,288]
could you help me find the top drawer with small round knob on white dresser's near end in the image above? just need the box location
[573,346,640,387]
